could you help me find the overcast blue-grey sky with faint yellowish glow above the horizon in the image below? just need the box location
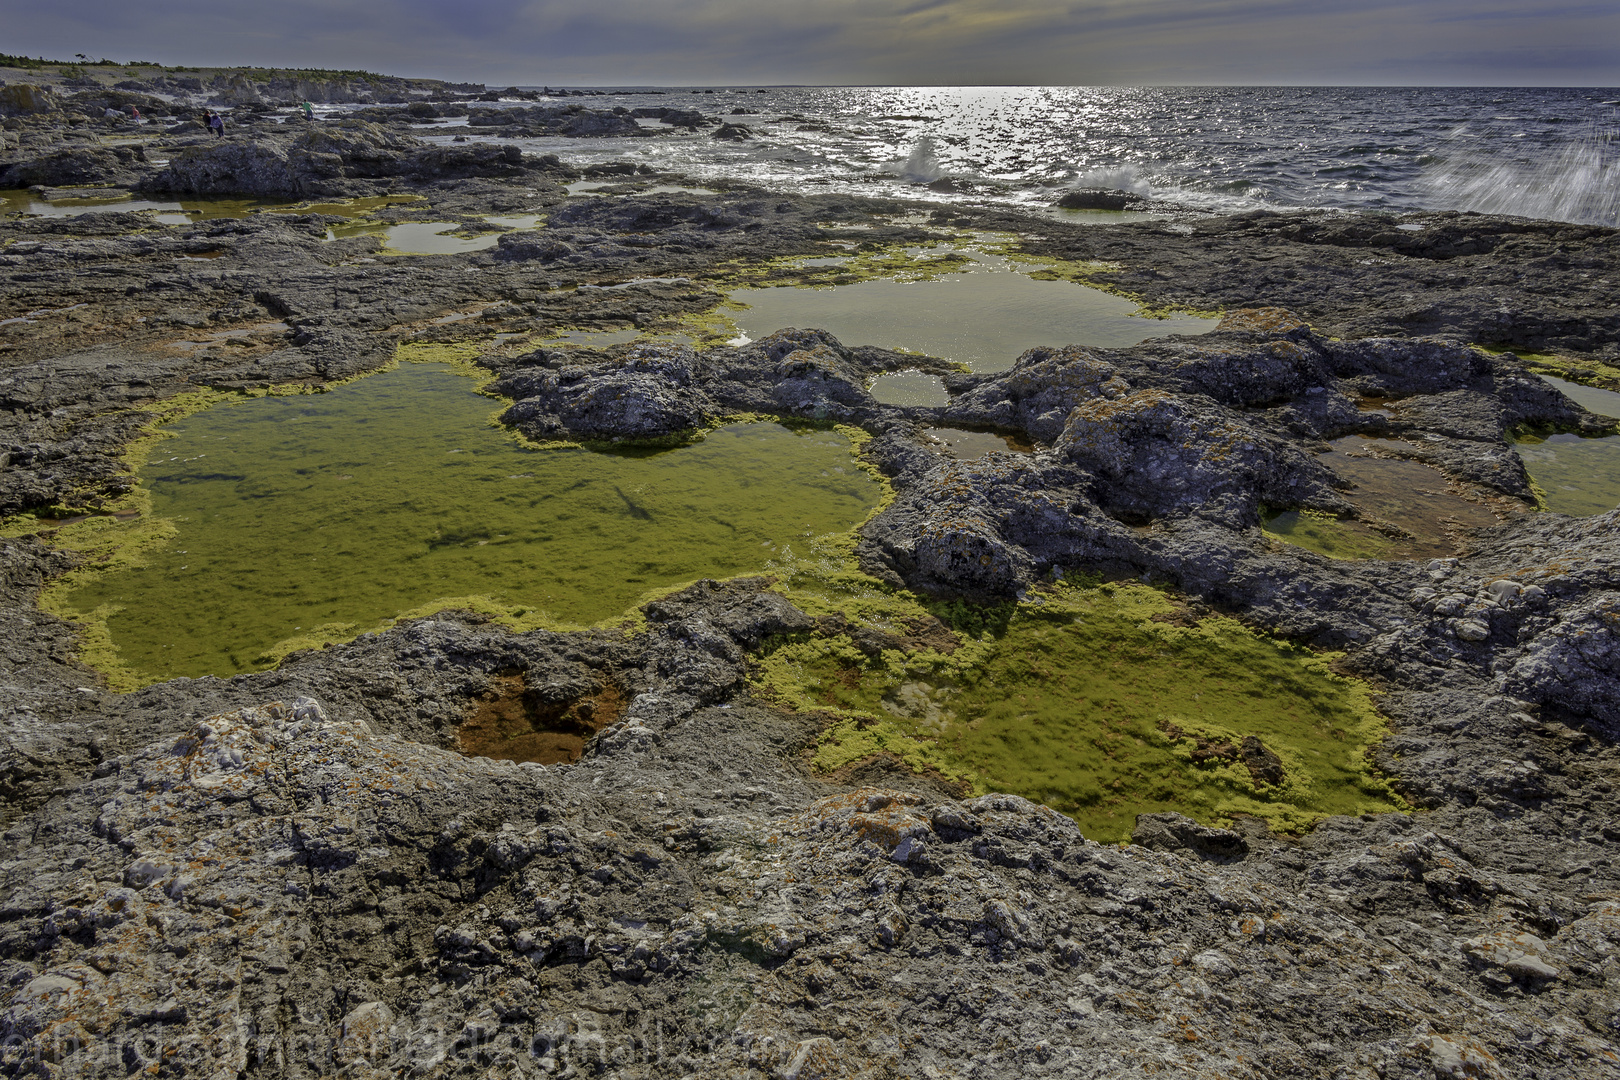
[12,0,1620,86]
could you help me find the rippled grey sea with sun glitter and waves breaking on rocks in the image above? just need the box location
[401,86,1620,225]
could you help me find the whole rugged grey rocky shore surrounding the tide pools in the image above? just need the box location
[0,76,1620,1080]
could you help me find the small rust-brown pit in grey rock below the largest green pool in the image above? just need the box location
[457,672,625,764]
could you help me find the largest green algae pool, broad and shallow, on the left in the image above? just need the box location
[55,363,883,685]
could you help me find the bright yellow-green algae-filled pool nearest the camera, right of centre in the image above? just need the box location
[755,551,1403,840]
